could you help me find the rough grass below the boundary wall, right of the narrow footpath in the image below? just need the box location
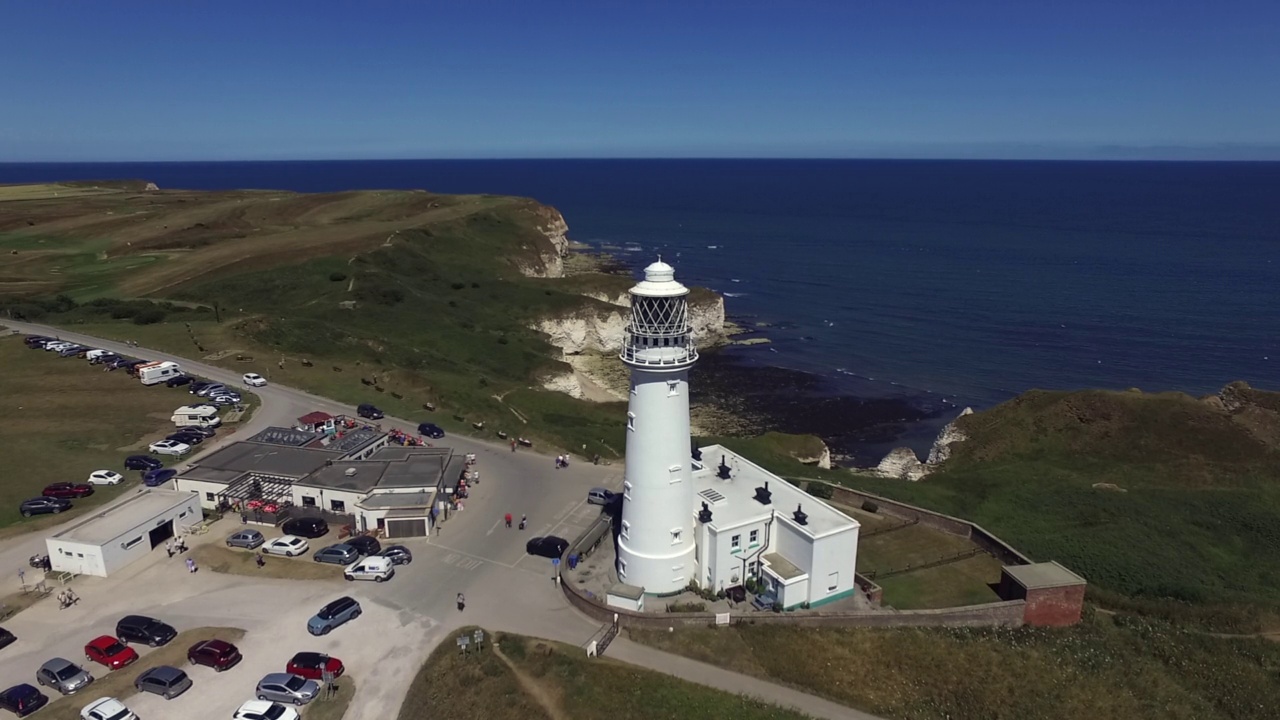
[628,616,1280,720]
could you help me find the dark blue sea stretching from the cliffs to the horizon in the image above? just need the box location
[0,160,1280,464]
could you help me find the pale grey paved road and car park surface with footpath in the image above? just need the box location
[0,322,872,720]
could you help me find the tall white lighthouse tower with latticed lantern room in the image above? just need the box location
[617,258,698,594]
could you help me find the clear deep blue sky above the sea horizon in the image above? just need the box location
[0,0,1280,161]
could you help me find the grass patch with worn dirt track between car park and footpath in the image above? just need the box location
[399,628,819,720]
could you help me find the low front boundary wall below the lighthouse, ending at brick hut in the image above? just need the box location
[561,583,1027,630]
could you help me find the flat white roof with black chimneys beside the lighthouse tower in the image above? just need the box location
[694,445,860,537]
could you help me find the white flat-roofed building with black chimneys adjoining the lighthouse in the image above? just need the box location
[609,445,860,610]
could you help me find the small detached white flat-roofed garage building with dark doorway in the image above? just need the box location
[45,488,204,578]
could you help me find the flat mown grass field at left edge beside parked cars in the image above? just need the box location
[0,336,200,533]
